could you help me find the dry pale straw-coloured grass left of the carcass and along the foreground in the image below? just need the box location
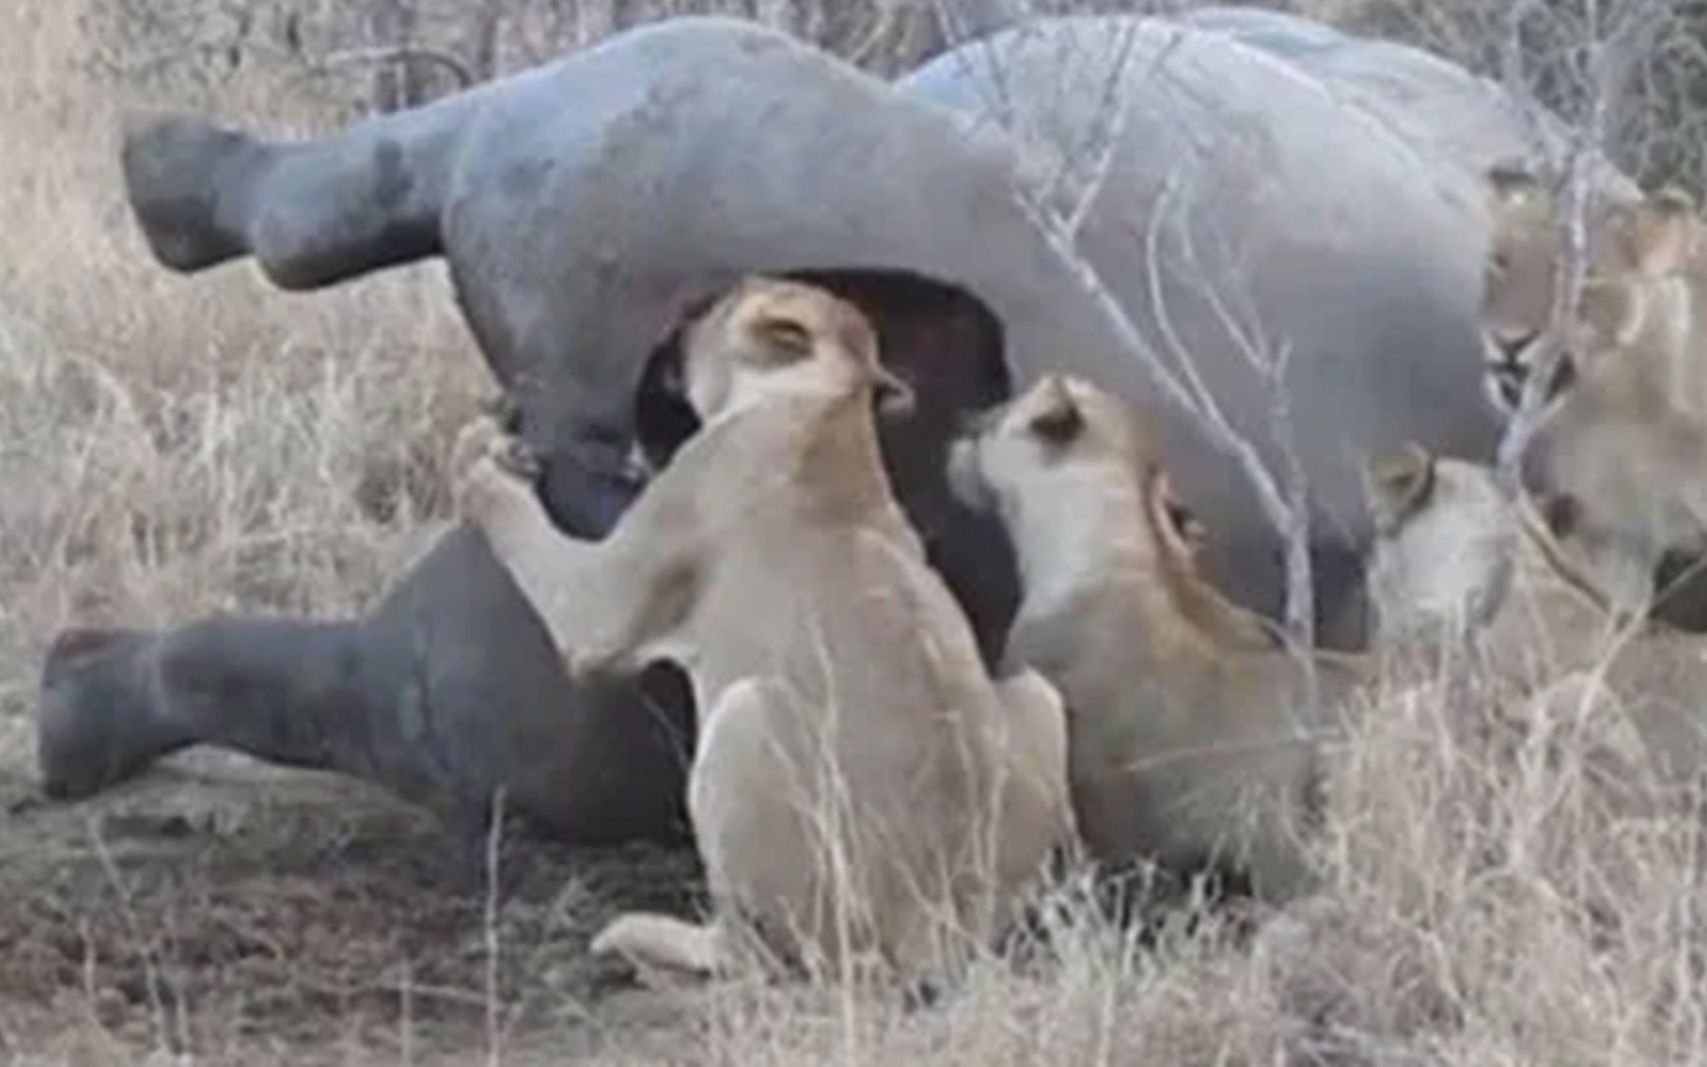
[10,0,1707,1067]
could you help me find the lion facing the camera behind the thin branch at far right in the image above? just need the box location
[1480,169,1707,611]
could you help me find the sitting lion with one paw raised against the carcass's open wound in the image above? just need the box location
[459,278,1072,975]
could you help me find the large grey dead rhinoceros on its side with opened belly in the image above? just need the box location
[41,12,1611,840]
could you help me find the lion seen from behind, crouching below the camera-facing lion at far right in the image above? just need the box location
[1367,446,1707,784]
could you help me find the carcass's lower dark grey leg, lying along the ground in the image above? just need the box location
[38,529,693,842]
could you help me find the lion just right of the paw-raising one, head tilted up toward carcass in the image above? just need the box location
[949,376,1350,898]
